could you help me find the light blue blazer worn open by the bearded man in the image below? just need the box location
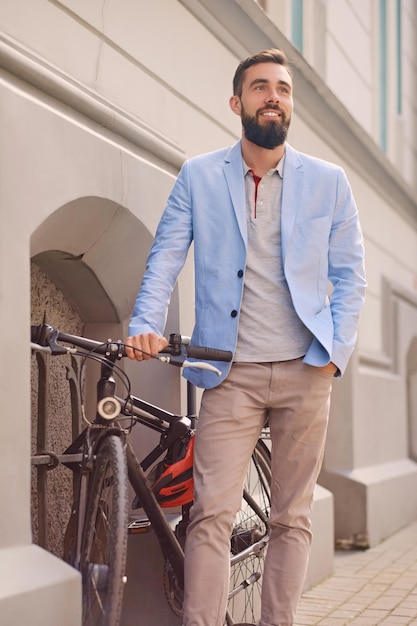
[129,142,366,388]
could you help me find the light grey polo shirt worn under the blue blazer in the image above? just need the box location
[234,157,313,363]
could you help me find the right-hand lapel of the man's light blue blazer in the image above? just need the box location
[281,144,304,261]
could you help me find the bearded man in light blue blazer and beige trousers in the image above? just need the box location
[126,50,365,626]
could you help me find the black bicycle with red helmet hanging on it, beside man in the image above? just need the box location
[31,324,271,626]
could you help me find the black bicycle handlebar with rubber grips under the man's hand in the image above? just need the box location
[31,324,233,365]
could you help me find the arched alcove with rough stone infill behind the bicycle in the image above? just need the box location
[31,197,180,556]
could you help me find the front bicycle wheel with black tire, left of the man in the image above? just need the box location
[80,435,128,626]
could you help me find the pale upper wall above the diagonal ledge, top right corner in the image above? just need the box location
[264,0,417,191]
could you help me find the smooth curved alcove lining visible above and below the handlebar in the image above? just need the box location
[30,196,180,404]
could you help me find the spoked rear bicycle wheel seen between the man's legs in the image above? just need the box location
[227,439,271,623]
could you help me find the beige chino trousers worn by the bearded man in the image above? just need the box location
[184,359,333,626]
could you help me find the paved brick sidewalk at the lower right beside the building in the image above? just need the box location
[294,522,417,626]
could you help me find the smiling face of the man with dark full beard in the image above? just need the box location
[231,63,293,150]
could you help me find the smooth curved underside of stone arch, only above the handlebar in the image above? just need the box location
[31,196,152,324]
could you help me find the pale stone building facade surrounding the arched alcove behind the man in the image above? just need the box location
[0,0,417,626]
